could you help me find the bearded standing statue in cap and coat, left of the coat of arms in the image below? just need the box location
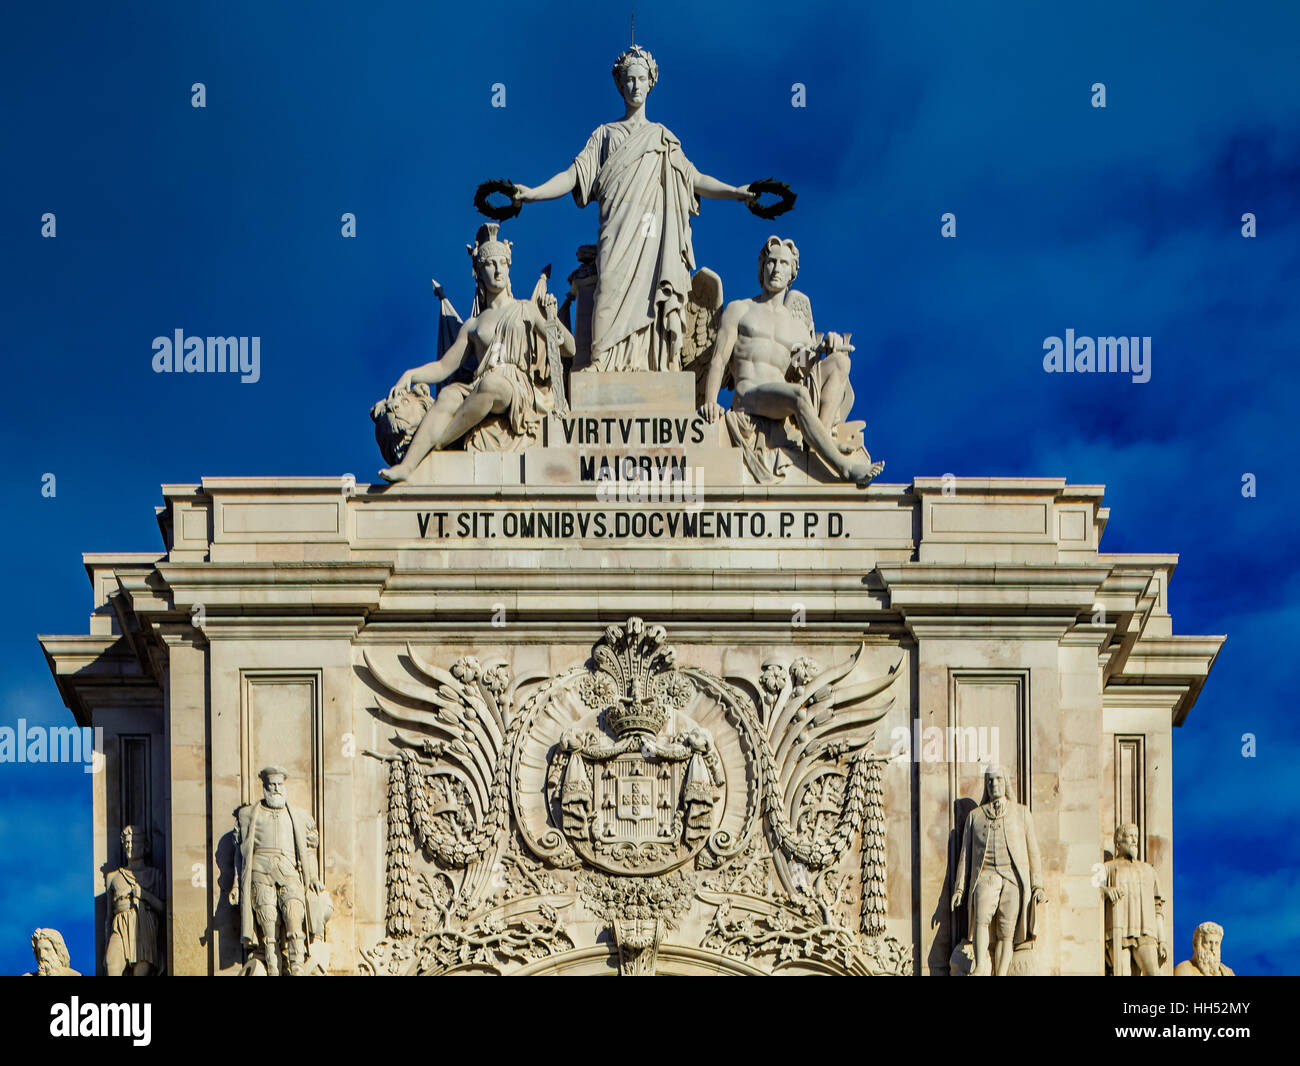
[230,766,329,976]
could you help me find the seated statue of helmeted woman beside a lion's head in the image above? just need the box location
[371,222,573,481]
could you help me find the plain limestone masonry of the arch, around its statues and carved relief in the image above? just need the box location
[43,395,1222,974]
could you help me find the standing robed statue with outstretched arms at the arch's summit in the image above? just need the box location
[514,44,757,371]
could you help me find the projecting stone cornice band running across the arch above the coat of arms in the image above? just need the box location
[42,477,1223,724]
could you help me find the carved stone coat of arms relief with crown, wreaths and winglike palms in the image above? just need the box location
[363,618,913,975]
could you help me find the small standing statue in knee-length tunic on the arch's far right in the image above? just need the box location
[1102,822,1169,978]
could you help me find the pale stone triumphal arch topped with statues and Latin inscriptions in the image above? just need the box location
[42,47,1222,976]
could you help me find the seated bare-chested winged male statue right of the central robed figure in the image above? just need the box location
[699,237,884,486]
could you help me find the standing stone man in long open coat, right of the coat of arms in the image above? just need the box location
[952,766,1047,978]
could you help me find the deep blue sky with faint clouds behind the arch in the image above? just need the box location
[0,0,1300,974]
